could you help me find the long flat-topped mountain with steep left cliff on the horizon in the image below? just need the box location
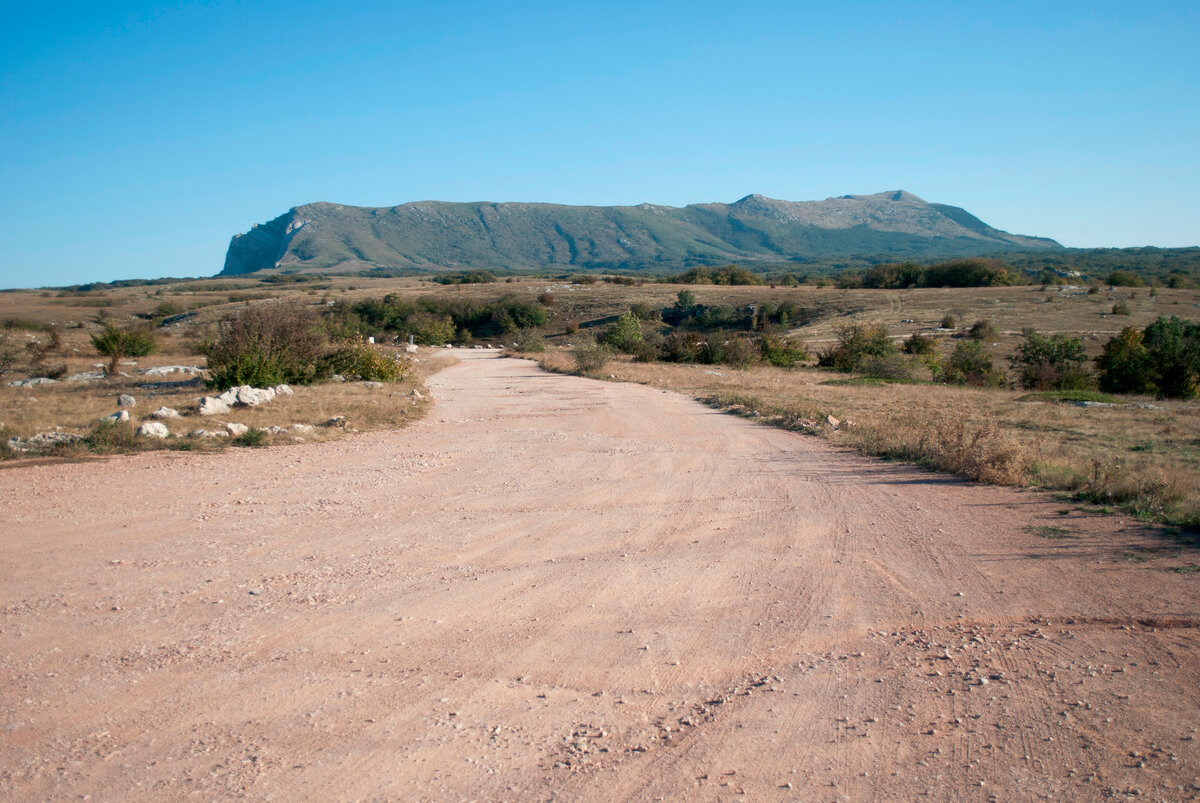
[221,191,1062,276]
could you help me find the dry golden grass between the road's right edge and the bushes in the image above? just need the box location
[532,352,1200,527]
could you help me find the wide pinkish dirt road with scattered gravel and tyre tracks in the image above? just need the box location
[0,352,1200,801]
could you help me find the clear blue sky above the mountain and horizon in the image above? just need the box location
[0,0,1200,287]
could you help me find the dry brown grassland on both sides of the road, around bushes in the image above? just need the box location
[0,276,1200,527]
